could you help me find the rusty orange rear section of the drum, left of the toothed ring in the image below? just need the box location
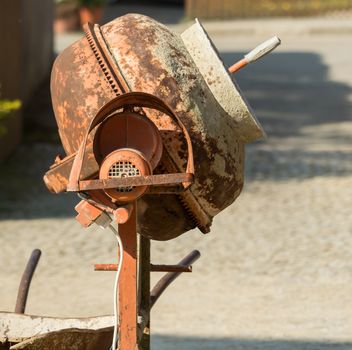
[51,38,116,155]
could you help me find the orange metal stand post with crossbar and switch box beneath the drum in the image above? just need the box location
[76,201,200,350]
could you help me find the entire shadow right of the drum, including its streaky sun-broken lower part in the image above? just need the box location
[221,52,352,180]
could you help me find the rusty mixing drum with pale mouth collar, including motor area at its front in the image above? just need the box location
[44,14,263,240]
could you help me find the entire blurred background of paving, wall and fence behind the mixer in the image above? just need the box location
[0,0,352,350]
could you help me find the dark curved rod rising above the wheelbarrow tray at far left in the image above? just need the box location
[15,249,42,314]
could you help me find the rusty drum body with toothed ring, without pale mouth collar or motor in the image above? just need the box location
[51,14,260,240]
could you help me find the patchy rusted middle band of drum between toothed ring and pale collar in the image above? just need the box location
[102,15,243,216]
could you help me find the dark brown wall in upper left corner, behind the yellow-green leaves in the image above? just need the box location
[0,0,54,160]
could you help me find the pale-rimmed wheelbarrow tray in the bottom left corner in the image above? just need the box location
[0,312,113,350]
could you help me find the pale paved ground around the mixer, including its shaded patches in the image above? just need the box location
[0,9,352,350]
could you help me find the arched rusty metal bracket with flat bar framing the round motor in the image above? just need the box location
[67,92,194,192]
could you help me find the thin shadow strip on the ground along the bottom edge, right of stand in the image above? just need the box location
[152,335,352,350]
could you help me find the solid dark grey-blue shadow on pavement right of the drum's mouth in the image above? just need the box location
[221,52,352,135]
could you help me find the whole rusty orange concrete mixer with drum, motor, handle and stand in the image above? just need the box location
[40,14,279,350]
